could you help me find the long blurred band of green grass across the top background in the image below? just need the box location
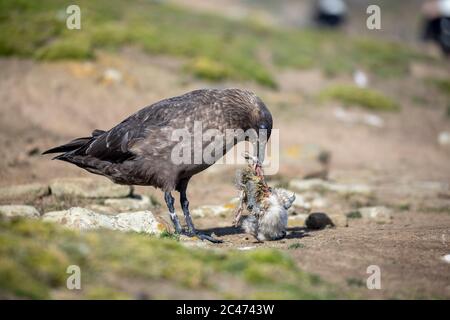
[0,0,426,88]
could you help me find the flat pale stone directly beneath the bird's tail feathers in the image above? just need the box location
[50,178,131,198]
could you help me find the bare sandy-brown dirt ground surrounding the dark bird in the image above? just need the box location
[0,43,450,298]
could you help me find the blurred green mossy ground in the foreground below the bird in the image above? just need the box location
[0,219,336,299]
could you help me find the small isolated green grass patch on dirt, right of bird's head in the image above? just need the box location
[319,85,400,111]
